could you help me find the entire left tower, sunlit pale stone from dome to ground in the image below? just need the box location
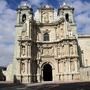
[13,1,33,83]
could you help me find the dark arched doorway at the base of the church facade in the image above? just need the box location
[43,64,52,81]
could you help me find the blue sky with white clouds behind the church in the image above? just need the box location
[0,0,90,66]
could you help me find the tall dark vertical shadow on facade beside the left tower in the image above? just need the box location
[30,21,41,83]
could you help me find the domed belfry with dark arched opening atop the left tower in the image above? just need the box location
[17,1,33,24]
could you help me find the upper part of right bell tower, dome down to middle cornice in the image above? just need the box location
[58,2,77,38]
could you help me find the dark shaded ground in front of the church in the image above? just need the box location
[0,82,90,90]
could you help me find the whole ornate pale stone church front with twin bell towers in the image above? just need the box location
[5,4,90,83]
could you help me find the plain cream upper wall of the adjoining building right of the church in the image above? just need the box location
[78,35,90,67]
